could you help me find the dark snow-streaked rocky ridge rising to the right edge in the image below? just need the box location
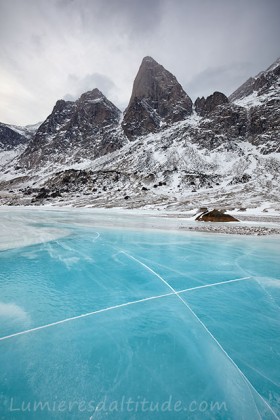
[192,60,280,154]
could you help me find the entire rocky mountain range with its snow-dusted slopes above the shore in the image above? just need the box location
[0,57,280,209]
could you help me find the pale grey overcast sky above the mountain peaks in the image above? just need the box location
[0,0,280,125]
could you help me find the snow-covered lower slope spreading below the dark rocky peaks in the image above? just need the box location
[19,117,280,208]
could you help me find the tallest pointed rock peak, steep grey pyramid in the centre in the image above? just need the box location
[122,57,192,139]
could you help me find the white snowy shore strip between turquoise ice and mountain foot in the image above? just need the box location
[0,205,280,250]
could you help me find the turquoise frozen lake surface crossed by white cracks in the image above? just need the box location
[0,210,280,420]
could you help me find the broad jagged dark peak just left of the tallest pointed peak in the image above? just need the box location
[21,89,124,167]
